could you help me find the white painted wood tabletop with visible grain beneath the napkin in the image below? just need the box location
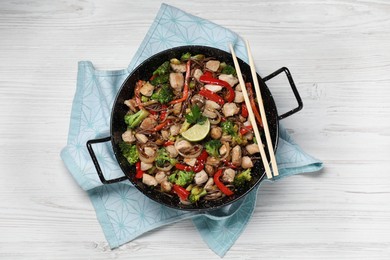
[0,0,390,259]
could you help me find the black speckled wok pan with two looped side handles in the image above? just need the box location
[87,46,303,211]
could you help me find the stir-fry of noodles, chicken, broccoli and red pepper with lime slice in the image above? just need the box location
[120,53,262,205]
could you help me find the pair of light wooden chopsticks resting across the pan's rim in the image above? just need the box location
[229,41,279,179]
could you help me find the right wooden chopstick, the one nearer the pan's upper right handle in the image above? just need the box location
[245,40,279,176]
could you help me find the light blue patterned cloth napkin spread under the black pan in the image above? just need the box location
[61,4,322,257]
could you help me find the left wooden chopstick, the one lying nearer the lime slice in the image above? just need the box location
[229,44,272,179]
